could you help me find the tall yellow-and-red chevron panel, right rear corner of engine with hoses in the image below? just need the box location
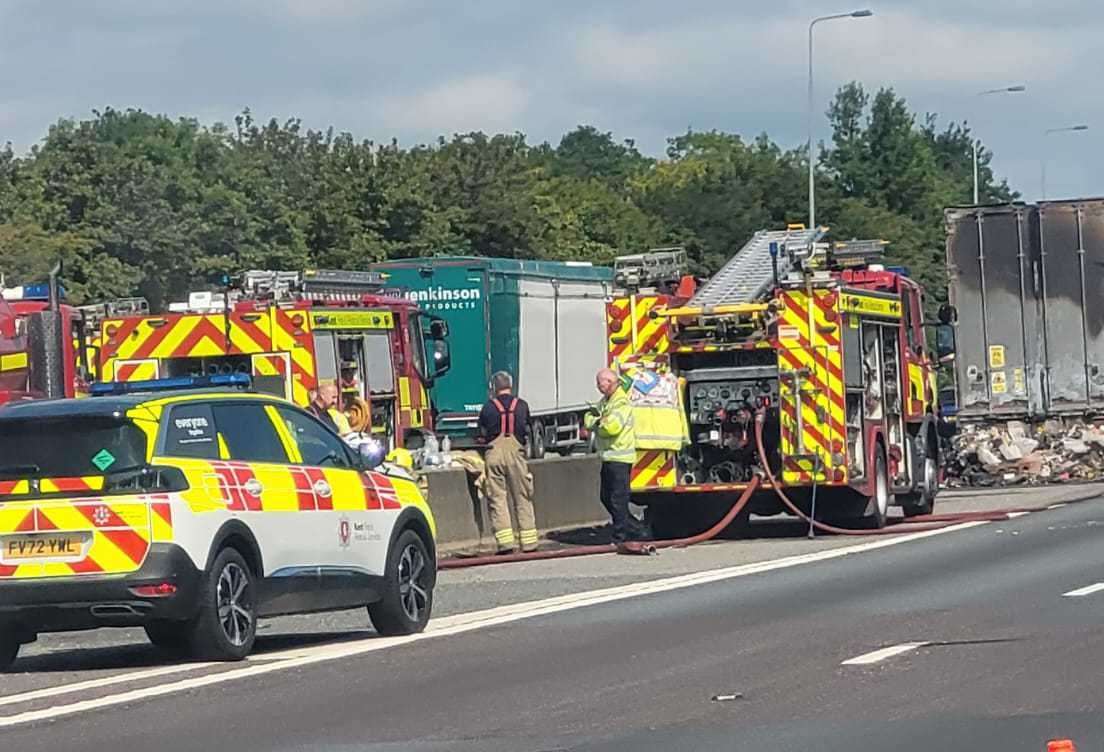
[776,290,847,484]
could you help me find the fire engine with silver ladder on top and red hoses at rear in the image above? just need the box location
[607,225,940,536]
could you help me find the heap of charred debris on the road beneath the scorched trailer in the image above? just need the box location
[943,420,1104,486]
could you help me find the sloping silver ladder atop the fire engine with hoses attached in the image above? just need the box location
[687,227,826,308]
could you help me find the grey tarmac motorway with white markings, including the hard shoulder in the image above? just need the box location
[0,483,1104,752]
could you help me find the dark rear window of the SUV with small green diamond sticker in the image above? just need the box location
[0,415,146,479]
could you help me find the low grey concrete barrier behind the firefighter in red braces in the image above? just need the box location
[426,457,609,553]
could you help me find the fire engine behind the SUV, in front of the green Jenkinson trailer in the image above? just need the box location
[96,269,450,447]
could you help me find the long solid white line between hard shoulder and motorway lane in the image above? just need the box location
[0,521,988,729]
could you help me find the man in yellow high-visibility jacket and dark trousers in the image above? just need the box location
[584,368,645,548]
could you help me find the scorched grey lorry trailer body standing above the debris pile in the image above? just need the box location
[945,199,1104,422]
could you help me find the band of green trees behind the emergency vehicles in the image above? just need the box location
[0,91,1016,306]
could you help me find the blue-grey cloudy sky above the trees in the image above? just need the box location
[0,0,1104,200]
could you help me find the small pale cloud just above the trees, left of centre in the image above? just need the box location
[375,75,530,134]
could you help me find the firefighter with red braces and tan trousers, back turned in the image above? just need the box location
[479,371,537,553]
